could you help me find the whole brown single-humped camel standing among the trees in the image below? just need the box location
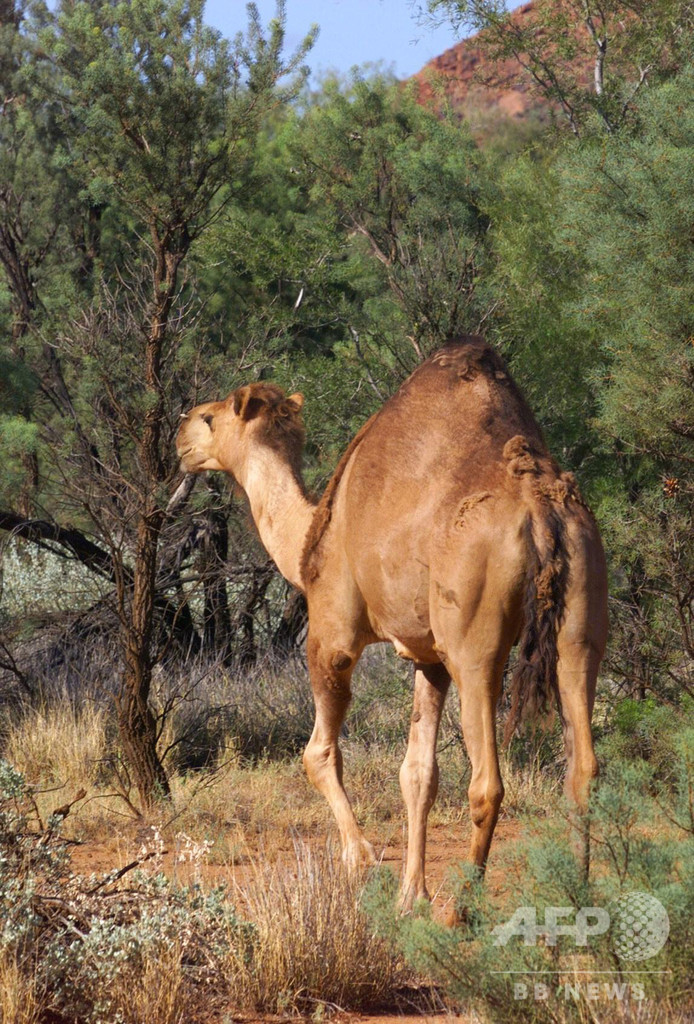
[177,336,607,908]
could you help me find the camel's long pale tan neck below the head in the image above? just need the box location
[238,449,315,590]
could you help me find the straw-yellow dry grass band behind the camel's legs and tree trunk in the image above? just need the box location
[4,706,561,864]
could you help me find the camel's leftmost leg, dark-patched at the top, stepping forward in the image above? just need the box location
[304,634,376,868]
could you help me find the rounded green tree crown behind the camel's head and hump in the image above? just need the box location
[191,74,495,458]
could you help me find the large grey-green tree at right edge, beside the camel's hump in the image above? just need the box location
[488,67,694,699]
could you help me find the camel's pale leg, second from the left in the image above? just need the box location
[400,665,450,910]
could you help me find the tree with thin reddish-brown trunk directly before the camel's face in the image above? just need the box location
[1,0,312,806]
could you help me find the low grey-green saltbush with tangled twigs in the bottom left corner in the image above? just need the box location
[0,761,253,1024]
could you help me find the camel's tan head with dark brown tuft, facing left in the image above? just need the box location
[176,383,304,479]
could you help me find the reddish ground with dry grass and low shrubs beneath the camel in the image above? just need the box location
[0,655,694,1024]
